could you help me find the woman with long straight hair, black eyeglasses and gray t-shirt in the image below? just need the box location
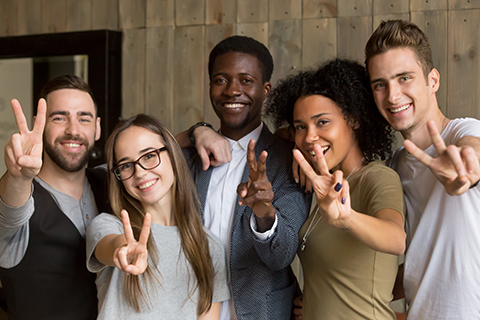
[87,114,229,320]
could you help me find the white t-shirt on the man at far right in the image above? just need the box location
[390,118,480,320]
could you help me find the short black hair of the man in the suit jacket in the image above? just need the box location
[208,36,273,83]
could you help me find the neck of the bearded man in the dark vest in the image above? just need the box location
[38,161,85,201]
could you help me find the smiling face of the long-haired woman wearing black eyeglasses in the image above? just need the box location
[114,126,175,214]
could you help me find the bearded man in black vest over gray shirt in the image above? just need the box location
[0,76,108,320]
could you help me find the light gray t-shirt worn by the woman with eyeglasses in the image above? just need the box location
[87,213,230,320]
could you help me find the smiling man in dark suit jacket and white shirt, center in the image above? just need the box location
[180,36,310,320]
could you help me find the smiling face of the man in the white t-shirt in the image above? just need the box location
[368,48,440,137]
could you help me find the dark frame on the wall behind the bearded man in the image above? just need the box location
[0,30,122,166]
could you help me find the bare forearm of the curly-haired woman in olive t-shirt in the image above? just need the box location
[341,209,406,255]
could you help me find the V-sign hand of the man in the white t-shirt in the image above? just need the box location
[404,121,480,196]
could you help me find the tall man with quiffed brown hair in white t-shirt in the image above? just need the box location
[365,20,480,320]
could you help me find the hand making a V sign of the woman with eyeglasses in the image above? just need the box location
[113,210,151,275]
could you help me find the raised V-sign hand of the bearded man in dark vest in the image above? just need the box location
[5,99,47,180]
